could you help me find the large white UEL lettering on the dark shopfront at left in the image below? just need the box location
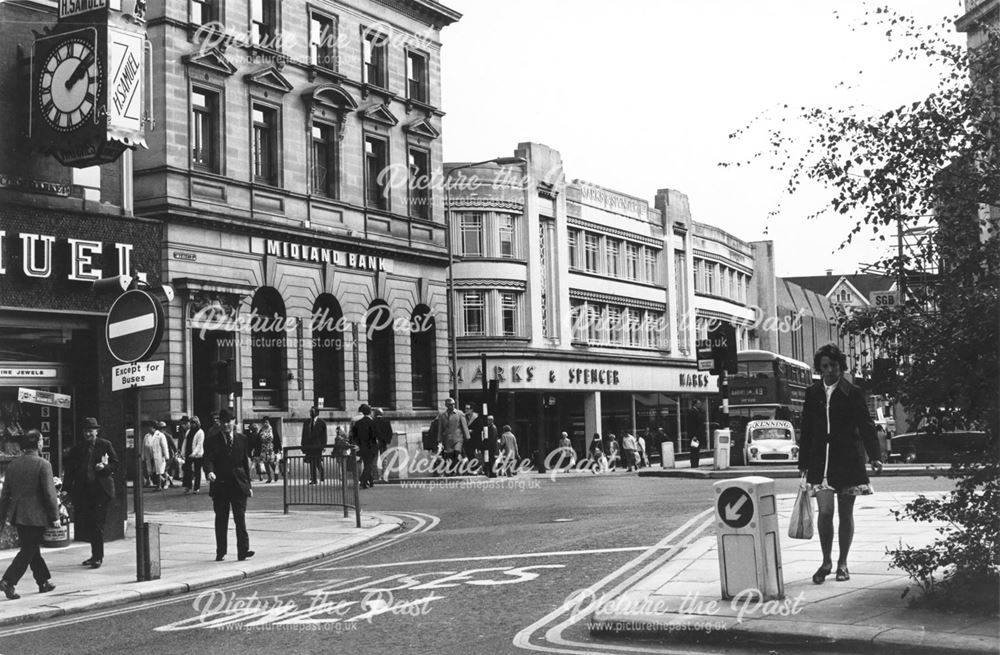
[0,230,132,282]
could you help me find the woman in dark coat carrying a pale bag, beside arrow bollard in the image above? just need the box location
[799,343,882,584]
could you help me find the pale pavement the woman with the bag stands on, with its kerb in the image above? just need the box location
[590,490,1000,654]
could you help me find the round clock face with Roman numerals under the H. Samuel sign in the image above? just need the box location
[38,39,101,132]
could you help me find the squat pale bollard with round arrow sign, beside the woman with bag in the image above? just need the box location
[714,476,785,600]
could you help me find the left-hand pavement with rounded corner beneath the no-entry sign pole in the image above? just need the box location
[0,508,400,625]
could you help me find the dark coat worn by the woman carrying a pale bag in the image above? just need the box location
[799,378,881,489]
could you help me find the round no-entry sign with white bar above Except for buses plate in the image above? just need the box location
[104,289,163,364]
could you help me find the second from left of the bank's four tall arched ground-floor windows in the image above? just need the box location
[312,293,344,409]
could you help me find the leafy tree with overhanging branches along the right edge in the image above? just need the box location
[724,8,1000,611]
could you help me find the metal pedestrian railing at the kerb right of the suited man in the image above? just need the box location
[281,448,361,528]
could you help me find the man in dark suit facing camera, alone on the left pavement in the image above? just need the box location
[204,409,254,562]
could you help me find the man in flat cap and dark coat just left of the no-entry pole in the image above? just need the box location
[65,417,118,569]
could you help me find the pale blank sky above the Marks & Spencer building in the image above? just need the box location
[441,0,964,276]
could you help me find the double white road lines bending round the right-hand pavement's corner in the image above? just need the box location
[513,507,715,655]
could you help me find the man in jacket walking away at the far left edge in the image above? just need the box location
[0,430,59,600]
